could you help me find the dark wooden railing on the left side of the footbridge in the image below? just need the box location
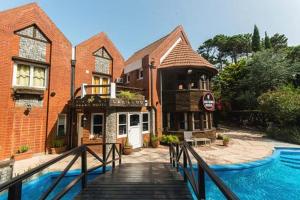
[0,143,122,200]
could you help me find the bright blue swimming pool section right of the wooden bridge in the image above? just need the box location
[206,148,300,200]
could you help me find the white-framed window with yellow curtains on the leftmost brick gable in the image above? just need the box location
[13,64,47,88]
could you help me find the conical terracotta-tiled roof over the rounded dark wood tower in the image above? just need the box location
[160,41,218,73]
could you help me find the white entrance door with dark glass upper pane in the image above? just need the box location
[128,114,142,149]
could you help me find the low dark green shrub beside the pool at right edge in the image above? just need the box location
[267,126,300,144]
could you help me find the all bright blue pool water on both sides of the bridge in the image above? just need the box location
[0,148,300,200]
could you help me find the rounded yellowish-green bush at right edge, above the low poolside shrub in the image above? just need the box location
[258,86,300,126]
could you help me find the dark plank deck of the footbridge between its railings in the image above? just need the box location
[75,163,193,200]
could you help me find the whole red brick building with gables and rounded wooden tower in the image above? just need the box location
[0,3,217,160]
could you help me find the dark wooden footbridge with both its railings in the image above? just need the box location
[0,142,238,200]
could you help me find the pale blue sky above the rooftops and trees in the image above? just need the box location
[0,0,300,59]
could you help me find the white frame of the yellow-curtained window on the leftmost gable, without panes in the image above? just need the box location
[12,61,48,89]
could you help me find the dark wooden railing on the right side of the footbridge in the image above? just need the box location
[169,141,238,200]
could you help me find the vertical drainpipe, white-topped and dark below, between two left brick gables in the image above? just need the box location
[68,47,76,148]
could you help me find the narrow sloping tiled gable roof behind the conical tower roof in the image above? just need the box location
[125,25,189,65]
